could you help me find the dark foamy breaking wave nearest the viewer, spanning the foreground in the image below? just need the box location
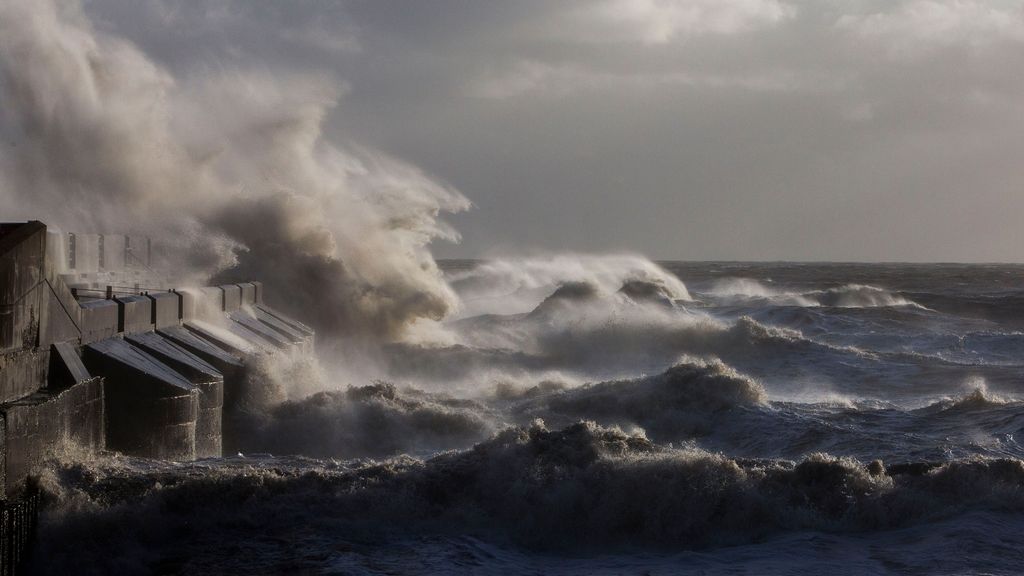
[36,422,1024,573]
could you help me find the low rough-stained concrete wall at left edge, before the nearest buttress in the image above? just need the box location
[0,378,103,494]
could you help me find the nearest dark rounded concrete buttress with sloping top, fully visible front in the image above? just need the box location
[83,338,200,460]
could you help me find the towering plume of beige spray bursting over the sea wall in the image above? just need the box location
[0,0,469,338]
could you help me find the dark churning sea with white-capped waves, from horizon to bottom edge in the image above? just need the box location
[28,261,1024,574]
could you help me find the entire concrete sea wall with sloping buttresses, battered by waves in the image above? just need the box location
[0,221,314,574]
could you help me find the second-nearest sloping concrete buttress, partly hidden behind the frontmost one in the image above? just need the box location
[125,332,224,458]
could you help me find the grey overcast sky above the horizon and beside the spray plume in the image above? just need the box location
[85,0,1024,261]
